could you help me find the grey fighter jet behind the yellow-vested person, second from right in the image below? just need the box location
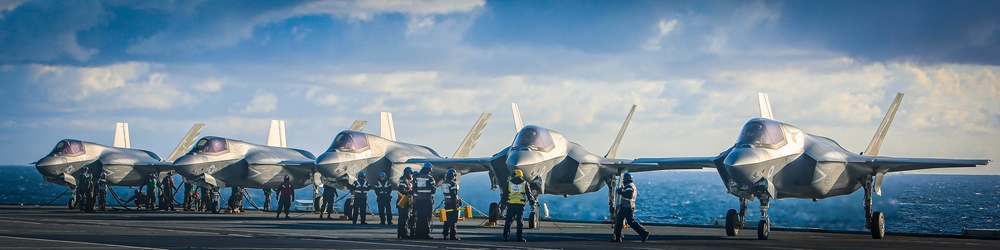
[410,103,673,228]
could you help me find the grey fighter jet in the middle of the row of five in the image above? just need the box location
[316,112,491,189]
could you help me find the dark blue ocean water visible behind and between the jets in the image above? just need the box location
[0,166,1000,235]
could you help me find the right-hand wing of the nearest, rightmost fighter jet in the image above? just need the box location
[849,157,991,173]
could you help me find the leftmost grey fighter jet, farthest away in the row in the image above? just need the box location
[34,122,205,207]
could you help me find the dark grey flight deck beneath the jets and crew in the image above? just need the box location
[0,205,1000,249]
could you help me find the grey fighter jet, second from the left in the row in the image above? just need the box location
[173,120,365,212]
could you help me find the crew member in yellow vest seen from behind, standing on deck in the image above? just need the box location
[501,169,535,242]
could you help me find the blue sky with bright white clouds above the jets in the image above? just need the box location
[0,0,1000,174]
